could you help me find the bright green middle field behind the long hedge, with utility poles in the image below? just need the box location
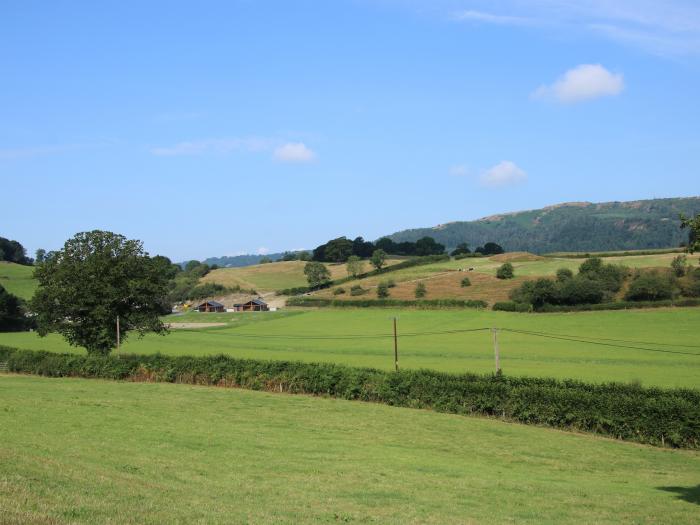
[0,308,700,388]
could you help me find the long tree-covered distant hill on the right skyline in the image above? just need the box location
[387,197,700,253]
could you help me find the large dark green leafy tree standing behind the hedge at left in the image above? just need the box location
[31,230,169,355]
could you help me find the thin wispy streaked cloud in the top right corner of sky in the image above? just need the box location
[452,0,700,56]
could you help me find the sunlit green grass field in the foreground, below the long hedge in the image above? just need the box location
[0,375,700,524]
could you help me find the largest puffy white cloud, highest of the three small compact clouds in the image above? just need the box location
[532,64,625,104]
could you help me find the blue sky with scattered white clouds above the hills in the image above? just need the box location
[0,0,700,261]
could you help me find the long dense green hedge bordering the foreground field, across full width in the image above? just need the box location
[0,347,700,448]
